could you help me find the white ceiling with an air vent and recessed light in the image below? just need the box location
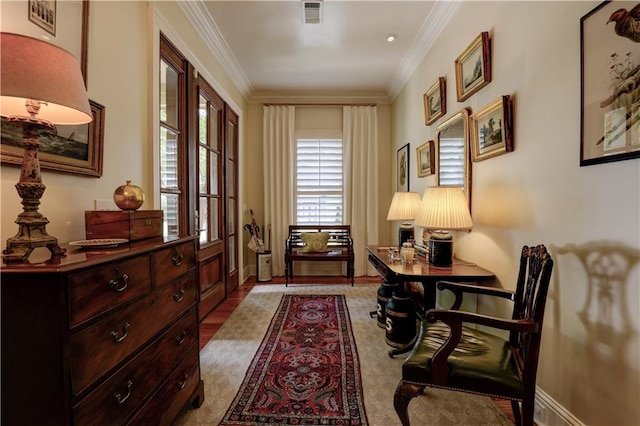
[180,0,458,101]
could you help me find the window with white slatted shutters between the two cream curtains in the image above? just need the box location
[295,139,344,225]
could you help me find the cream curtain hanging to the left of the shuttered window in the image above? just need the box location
[262,105,295,276]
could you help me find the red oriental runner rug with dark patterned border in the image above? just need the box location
[220,294,367,426]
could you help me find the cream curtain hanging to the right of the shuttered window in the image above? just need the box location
[342,106,379,276]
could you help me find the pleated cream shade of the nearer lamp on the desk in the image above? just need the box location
[415,186,473,230]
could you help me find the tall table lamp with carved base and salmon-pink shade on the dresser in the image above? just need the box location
[0,32,93,261]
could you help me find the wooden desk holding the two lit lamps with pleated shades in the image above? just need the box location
[366,246,495,356]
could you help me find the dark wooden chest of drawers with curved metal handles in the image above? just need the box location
[0,237,204,426]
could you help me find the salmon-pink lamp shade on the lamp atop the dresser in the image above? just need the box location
[0,33,93,125]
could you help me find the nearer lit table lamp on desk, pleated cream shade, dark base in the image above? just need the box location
[415,186,473,267]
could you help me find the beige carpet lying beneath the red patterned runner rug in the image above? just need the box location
[175,284,511,426]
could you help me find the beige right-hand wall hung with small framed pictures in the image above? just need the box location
[389,2,640,425]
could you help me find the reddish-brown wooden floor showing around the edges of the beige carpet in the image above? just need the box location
[195,277,514,421]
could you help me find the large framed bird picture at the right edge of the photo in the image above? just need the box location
[580,1,640,166]
